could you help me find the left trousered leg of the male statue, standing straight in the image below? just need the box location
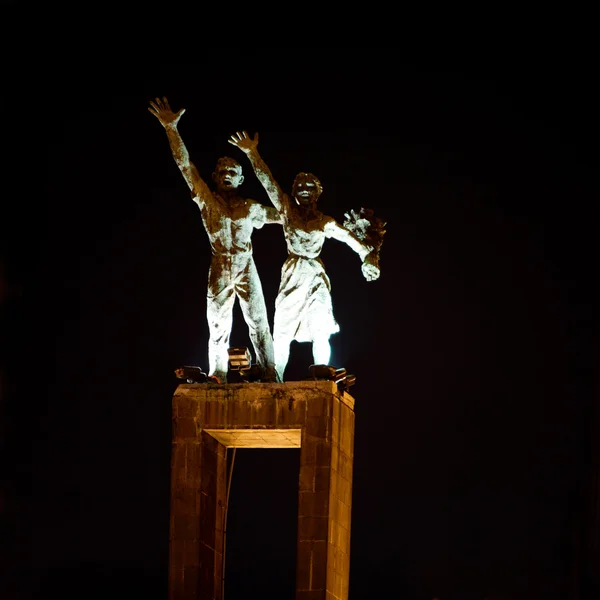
[206,286,235,383]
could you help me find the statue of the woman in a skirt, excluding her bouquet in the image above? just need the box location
[229,131,379,381]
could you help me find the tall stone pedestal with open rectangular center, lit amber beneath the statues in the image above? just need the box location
[169,381,354,600]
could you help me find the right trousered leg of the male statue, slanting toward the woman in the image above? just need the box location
[236,260,275,381]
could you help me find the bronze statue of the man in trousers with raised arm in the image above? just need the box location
[148,97,281,383]
